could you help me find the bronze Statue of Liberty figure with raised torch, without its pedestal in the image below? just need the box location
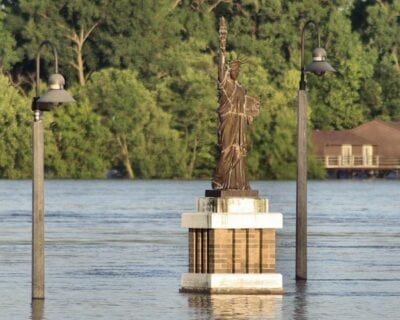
[212,17,260,190]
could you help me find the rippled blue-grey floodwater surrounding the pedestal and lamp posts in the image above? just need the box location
[0,180,400,320]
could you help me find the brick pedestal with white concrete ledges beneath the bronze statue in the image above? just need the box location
[180,195,283,294]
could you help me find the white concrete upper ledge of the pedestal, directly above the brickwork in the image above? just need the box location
[181,212,283,229]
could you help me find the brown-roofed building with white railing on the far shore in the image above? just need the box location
[312,120,400,177]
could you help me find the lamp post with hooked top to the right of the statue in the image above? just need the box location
[296,20,336,280]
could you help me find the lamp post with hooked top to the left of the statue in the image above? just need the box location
[32,41,74,300]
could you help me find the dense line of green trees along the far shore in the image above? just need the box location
[0,0,400,179]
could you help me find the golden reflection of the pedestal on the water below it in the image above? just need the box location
[187,294,282,320]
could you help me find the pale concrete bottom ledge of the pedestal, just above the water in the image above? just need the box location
[180,273,283,295]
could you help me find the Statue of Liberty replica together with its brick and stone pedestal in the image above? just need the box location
[180,18,283,294]
